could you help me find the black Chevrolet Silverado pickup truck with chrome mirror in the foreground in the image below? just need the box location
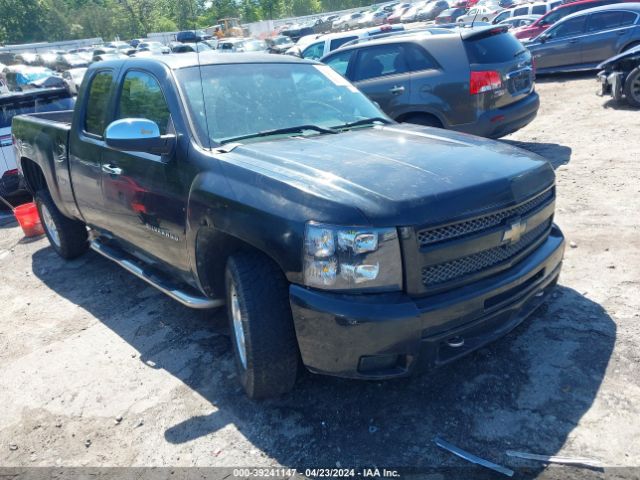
[13,53,564,398]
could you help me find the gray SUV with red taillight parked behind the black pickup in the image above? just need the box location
[321,26,540,138]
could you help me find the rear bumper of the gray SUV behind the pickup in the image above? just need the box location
[451,91,540,138]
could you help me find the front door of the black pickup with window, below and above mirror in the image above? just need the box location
[96,69,190,271]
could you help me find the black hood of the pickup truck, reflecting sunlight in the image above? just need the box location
[225,124,554,226]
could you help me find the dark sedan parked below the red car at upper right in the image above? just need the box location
[526,3,640,73]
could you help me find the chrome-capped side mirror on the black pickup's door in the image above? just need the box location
[104,118,176,155]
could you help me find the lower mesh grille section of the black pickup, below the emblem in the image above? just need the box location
[422,219,551,287]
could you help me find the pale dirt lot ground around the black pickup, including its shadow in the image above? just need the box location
[0,76,640,474]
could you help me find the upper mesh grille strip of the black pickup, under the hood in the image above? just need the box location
[418,188,554,247]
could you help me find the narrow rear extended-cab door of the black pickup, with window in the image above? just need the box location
[69,69,115,227]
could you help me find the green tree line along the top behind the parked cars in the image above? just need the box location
[0,0,373,44]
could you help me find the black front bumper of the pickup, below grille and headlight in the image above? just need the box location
[290,226,564,379]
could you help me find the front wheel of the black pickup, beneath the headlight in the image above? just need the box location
[225,252,300,399]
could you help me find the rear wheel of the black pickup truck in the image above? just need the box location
[35,190,89,260]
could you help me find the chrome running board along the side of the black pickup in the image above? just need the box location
[91,239,224,309]
